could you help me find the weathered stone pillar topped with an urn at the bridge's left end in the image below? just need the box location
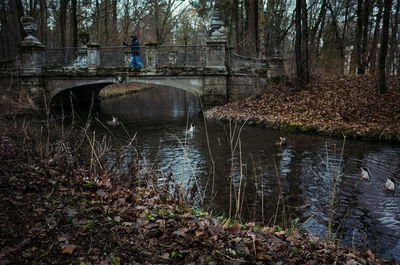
[18,16,47,106]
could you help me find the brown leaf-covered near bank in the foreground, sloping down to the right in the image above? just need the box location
[0,121,396,265]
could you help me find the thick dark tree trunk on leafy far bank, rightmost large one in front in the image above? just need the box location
[378,0,392,94]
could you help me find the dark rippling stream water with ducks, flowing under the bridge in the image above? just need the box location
[72,87,400,262]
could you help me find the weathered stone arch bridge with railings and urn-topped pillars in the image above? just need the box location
[0,16,283,105]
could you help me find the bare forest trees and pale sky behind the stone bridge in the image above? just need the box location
[0,0,400,82]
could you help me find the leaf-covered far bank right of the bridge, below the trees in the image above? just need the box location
[205,74,400,142]
